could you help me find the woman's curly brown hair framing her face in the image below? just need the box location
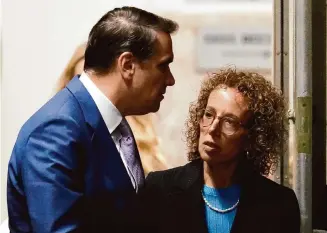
[185,68,286,175]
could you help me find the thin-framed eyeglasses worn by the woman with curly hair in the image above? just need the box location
[201,110,244,136]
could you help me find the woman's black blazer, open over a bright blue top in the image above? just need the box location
[140,160,300,233]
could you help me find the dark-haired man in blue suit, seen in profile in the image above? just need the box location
[7,7,178,233]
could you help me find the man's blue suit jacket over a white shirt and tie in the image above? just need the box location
[7,77,135,233]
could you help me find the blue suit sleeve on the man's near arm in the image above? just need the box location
[22,118,84,233]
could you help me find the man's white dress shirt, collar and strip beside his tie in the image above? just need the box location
[79,72,136,188]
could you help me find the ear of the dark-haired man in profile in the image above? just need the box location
[117,52,136,80]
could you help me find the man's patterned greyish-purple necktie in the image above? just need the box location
[118,118,145,191]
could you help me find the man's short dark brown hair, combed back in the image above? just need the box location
[84,7,178,74]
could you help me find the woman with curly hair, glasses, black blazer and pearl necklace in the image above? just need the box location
[141,69,300,233]
